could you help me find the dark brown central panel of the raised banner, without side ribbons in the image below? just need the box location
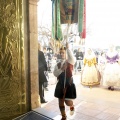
[60,0,79,24]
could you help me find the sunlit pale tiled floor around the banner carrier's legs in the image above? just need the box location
[33,73,120,120]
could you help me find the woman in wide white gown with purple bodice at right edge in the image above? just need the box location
[103,45,120,90]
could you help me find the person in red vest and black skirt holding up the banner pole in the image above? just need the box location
[53,44,76,120]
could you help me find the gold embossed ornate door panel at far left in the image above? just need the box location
[0,0,27,120]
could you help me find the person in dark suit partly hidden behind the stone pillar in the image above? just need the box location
[38,43,48,103]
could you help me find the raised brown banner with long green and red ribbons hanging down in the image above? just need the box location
[52,0,86,40]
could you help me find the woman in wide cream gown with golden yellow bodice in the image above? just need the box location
[81,48,100,87]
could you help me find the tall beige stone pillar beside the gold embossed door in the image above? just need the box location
[29,0,40,109]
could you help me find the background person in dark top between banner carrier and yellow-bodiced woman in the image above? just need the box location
[75,48,83,73]
